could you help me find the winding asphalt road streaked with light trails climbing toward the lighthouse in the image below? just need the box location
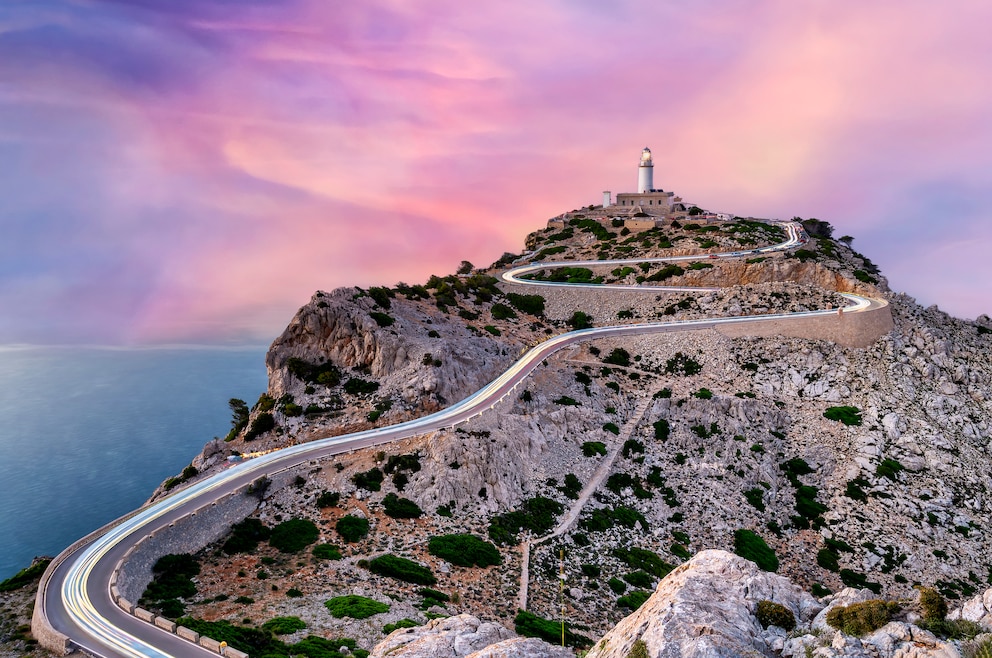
[35,222,885,658]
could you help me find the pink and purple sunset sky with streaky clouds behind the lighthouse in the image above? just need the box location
[0,0,992,345]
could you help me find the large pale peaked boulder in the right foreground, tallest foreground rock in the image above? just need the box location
[587,550,821,658]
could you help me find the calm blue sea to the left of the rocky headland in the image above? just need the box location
[0,346,267,581]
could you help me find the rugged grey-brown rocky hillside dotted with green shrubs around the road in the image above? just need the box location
[140,213,992,655]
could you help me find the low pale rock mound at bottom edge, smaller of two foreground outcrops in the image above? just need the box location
[370,615,572,658]
